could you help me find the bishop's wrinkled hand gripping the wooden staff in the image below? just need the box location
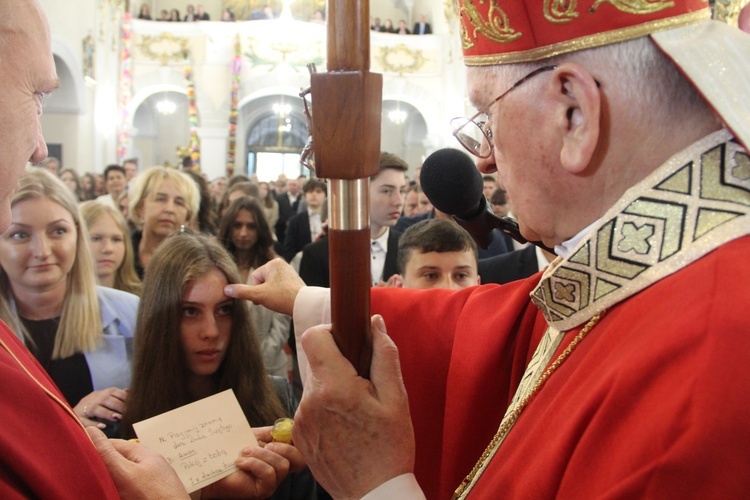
[292,316,414,498]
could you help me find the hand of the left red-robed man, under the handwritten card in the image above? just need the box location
[86,427,188,500]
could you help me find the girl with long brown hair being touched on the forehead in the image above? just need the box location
[123,233,315,498]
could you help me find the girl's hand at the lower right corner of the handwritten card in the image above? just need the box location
[202,427,306,498]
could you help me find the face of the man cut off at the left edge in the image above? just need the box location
[0,0,58,232]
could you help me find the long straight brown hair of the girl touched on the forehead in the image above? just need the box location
[122,233,285,438]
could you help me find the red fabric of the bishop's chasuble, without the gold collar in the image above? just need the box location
[372,237,750,499]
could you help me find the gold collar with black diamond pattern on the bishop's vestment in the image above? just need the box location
[531,130,750,331]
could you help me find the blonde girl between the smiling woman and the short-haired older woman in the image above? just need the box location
[79,201,141,295]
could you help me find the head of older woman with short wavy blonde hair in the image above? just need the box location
[128,167,200,278]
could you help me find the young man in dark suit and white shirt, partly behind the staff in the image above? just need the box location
[299,153,408,287]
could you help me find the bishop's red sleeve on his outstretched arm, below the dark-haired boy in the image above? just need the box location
[371,275,546,498]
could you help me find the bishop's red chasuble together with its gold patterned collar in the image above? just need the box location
[372,131,750,499]
